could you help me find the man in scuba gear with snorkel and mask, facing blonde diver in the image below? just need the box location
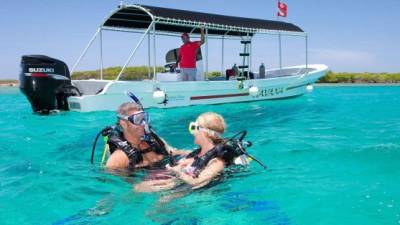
[91,93,188,170]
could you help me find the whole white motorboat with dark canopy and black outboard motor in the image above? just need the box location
[20,5,328,112]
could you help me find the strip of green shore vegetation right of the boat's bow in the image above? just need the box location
[318,71,400,83]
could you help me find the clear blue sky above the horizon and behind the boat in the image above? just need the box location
[0,0,400,79]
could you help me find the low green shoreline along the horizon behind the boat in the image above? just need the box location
[0,66,400,87]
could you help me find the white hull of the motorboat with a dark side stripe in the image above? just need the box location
[68,65,328,112]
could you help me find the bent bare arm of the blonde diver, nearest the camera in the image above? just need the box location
[172,158,225,189]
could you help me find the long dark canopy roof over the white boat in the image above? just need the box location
[102,5,306,36]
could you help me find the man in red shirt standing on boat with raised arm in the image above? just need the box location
[175,28,205,81]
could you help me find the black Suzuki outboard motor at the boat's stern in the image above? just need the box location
[19,55,81,114]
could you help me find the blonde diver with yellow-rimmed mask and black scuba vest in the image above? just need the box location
[134,112,265,192]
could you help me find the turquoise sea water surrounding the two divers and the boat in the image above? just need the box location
[0,87,400,225]
